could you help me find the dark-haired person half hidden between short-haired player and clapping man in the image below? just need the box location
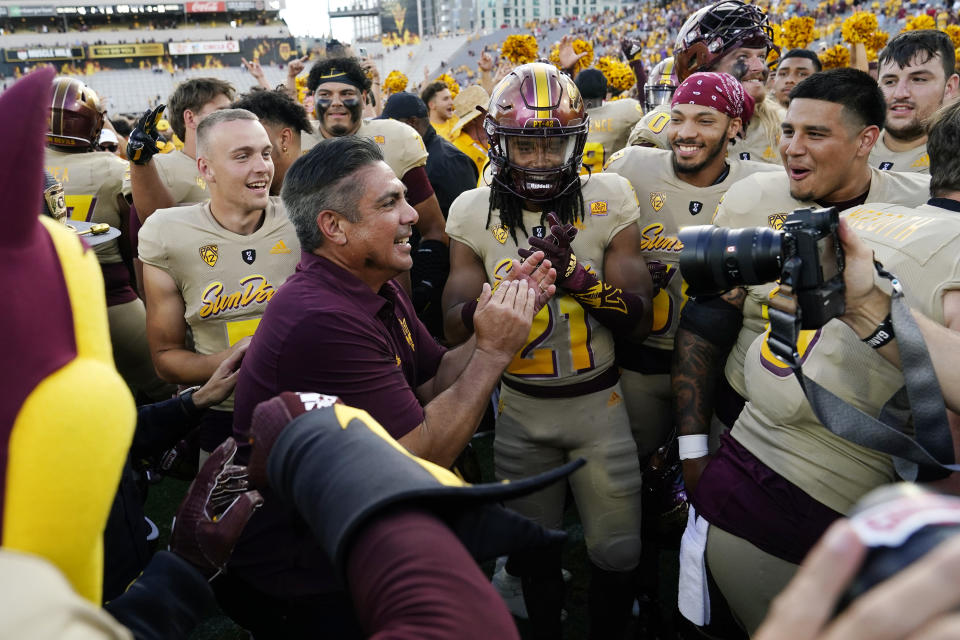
[233,90,313,196]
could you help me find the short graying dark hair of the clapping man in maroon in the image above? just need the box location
[280,136,383,252]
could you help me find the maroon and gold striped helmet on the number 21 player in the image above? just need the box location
[484,62,589,202]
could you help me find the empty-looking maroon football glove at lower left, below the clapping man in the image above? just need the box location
[170,438,263,580]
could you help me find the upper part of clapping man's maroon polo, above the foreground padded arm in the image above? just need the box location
[233,252,444,438]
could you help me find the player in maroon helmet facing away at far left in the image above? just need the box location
[44,78,172,400]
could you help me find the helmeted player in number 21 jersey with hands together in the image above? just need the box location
[443,63,651,638]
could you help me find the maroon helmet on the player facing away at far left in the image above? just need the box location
[47,78,105,151]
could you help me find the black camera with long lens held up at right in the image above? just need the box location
[679,207,845,329]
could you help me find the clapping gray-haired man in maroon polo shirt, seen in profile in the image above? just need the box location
[224,136,555,639]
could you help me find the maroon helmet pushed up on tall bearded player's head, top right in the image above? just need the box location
[673,0,780,82]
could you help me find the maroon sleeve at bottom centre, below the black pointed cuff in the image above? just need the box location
[347,511,520,640]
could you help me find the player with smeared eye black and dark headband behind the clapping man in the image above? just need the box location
[307,58,450,312]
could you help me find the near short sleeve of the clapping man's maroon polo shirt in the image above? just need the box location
[276,313,432,439]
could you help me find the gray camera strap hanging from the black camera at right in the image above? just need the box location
[767,260,960,482]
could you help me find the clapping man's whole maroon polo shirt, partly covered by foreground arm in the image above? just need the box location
[230,252,444,601]
